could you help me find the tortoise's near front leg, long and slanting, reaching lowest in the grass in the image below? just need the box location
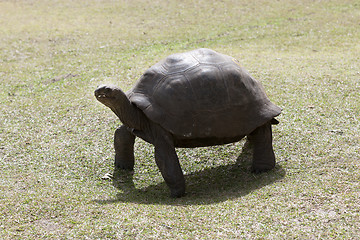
[154,125,185,197]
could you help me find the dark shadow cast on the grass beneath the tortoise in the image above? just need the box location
[95,145,285,205]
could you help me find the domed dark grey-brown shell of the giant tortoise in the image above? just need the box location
[128,49,281,139]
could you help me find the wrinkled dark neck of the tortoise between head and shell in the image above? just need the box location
[110,90,145,130]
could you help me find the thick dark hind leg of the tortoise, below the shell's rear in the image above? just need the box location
[248,122,275,173]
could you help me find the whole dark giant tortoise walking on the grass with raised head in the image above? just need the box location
[95,48,281,197]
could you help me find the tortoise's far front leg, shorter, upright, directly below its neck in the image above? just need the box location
[114,125,135,170]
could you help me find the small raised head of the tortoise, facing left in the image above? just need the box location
[94,85,125,108]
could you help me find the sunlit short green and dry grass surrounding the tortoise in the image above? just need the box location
[0,0,360,239]
